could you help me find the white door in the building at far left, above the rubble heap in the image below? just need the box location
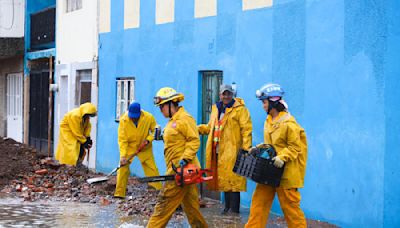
[7,73,23,142]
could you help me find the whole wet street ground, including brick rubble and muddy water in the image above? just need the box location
[0,137,335,228]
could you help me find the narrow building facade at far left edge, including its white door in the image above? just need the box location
[0,0,25,142]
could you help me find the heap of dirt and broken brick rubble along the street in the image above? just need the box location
[0,135,183,219]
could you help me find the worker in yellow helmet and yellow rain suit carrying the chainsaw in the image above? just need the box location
[147,87,208,228]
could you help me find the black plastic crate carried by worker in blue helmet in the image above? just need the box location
[233,150,284,187]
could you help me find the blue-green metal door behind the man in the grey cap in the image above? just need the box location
[200,70,222,199]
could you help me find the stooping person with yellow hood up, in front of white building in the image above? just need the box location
[56,103,97,166]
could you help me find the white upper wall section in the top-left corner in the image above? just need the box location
[0,0,25,38]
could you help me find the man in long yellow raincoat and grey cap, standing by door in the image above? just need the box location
[198,85,252,214]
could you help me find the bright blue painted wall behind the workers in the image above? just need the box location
[96,0,400,227]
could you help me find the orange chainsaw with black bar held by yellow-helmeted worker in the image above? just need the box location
[138,164,213,187]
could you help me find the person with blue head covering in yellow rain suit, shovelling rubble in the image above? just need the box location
[114,102,161,198]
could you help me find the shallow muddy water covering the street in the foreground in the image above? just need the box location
[0,197,248,228]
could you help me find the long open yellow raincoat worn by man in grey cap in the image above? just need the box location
[198,98,252,192]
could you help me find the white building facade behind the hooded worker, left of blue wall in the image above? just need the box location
[54,0,98,169]
